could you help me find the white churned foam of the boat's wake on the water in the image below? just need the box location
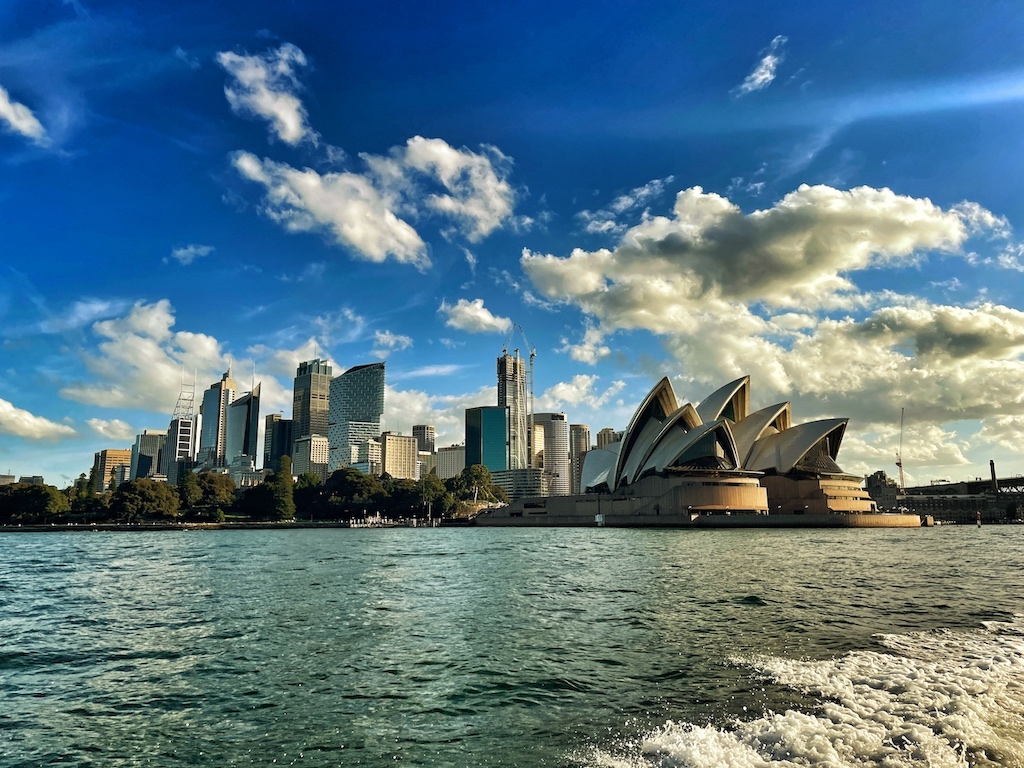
[588,616,1024,768]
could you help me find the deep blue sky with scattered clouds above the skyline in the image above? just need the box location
[0,0,1024,486]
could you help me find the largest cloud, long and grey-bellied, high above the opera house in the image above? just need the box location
[521,184,995,319]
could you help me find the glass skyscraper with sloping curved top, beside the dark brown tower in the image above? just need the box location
[327,362,384,472]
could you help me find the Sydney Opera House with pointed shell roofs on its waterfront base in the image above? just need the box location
[476,376,921,527]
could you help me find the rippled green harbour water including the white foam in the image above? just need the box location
[0,525,1024,768]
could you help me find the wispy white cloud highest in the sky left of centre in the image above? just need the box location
[217,43,317,145]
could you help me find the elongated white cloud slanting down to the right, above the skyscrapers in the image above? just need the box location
[232,152,430,268]
